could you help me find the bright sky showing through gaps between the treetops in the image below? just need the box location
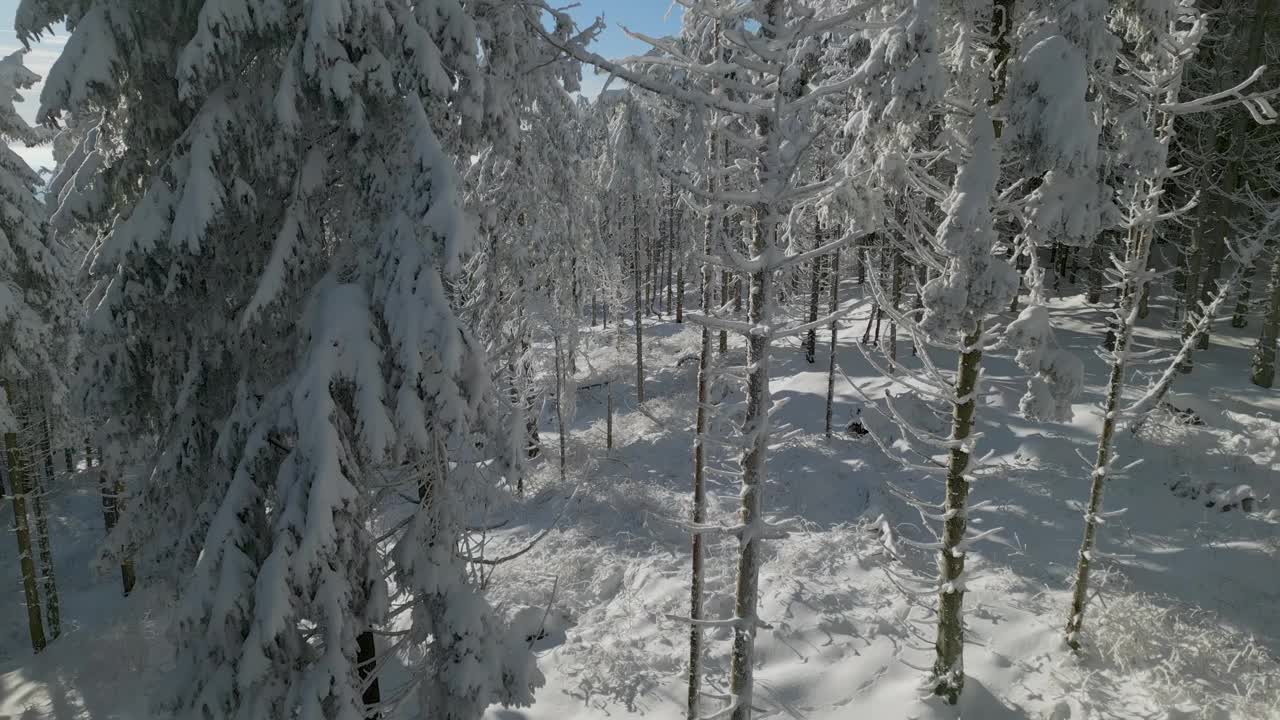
[0,0,680,168]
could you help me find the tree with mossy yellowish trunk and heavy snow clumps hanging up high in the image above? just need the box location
[849,0,1115,703]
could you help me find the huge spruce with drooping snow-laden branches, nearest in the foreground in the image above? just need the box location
[19,0,588,719]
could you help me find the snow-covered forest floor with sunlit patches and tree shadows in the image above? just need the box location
[0,283,1280,720]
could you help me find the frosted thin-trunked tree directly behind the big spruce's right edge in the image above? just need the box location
[456,77,593,476]
